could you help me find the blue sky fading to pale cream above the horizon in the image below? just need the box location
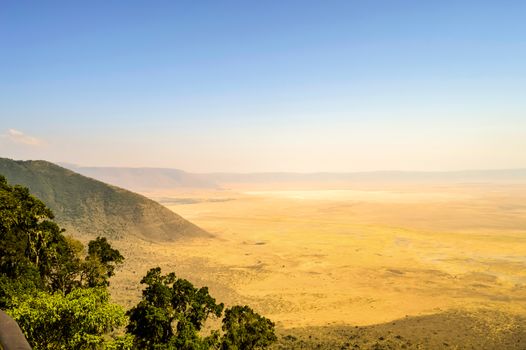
[0,0,526,172]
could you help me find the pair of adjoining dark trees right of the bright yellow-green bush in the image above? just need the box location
[127,268,277,350]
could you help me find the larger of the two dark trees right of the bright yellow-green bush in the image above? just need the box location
[127,267,224,349]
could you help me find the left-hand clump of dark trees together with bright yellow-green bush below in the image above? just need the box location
[0,176,126,349]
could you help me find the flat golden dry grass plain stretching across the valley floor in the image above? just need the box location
[112,184,526,348]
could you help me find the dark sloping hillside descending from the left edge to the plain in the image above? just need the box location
[0,158,209,241]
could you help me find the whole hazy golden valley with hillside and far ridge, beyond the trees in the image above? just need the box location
[0,159,526,349]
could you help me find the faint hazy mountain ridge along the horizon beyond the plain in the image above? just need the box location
[59,164,526,192]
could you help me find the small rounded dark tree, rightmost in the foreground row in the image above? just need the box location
[221,305,277,350]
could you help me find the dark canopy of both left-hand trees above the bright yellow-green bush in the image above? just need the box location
[0,176,124,298]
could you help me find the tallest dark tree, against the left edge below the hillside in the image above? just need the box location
[0,176,82,294]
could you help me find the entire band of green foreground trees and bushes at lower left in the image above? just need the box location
[0,176,276,350]
